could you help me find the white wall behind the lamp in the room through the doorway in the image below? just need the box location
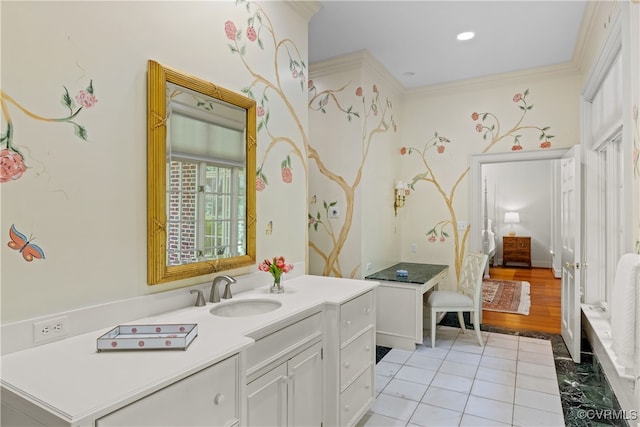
[482,160,553,268]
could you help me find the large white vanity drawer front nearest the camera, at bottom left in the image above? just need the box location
[96,356,240,427]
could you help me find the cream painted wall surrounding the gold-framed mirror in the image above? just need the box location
[0,2,310,323]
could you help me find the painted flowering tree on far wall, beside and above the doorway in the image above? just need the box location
[408,89,554,277]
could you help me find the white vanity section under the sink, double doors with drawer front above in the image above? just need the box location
[246,312,323,427]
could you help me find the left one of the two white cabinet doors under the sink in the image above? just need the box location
[247,363,287,427]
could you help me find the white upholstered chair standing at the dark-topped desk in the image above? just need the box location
[427,252,488,347]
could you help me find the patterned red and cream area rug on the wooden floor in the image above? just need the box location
[482,279,531,316]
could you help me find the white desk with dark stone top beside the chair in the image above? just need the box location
[365,262,449,350]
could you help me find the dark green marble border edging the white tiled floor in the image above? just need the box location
[376,313,629,427]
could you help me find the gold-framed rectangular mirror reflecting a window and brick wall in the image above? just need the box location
[147,60,256,285]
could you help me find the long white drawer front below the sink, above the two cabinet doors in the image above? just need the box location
[246,313,322,380]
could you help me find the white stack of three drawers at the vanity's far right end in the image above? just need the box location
[324,291,376,427]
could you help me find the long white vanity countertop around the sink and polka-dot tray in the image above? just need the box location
[0,275,376,423]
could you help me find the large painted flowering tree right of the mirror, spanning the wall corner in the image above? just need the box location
[225,0,396,276]
